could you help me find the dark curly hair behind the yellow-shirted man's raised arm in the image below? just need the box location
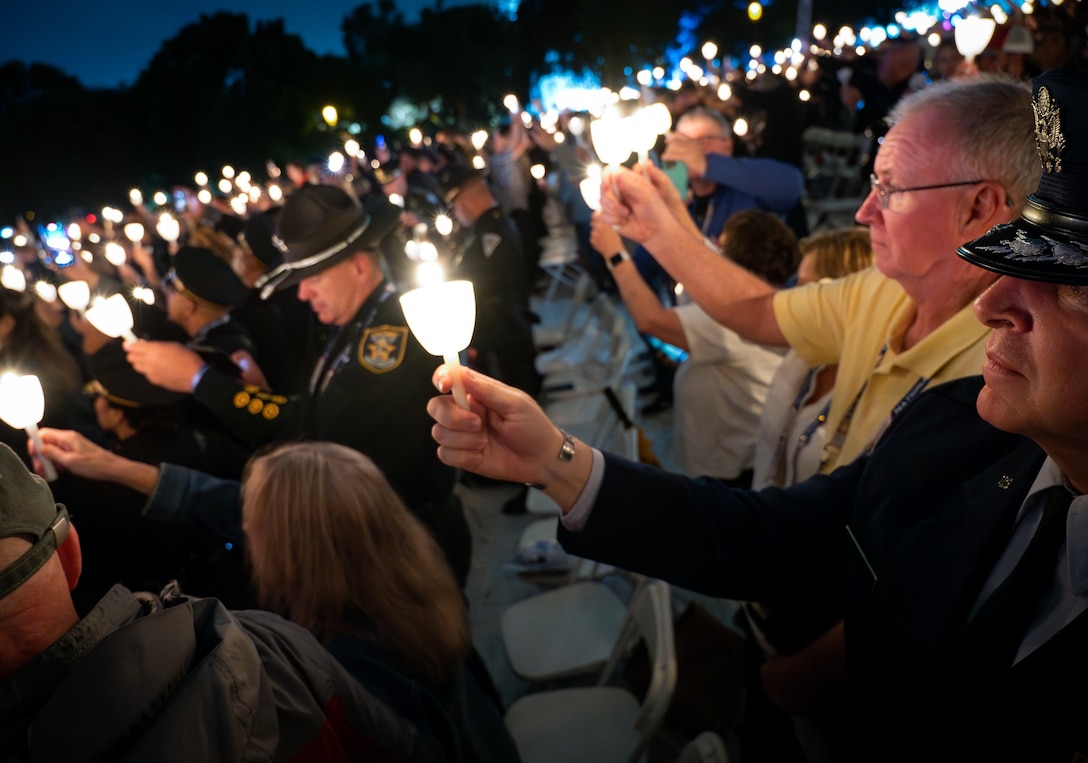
[721,209,801,286]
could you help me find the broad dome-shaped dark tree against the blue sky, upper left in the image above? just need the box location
[132,13,349,182]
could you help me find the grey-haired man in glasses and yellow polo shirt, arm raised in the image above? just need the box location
[602,78,1041,753]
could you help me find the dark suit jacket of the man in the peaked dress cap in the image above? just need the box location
[559,377,1088,761]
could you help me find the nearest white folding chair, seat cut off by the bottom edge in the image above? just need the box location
[506,580,677,763]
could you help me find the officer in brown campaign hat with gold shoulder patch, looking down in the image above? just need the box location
[126,185,471,582]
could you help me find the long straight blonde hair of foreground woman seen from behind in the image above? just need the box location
[243,442,469,684]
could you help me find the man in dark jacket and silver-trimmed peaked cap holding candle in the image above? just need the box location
[430,70,1088,762]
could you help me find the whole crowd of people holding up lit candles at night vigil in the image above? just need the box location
[0,11,1088,761]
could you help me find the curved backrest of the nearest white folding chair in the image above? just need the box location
[599,580,677,761]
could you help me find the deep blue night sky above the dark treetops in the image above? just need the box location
[0,0,479,88]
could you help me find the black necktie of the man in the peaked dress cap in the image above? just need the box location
[959,485,1073,681]
